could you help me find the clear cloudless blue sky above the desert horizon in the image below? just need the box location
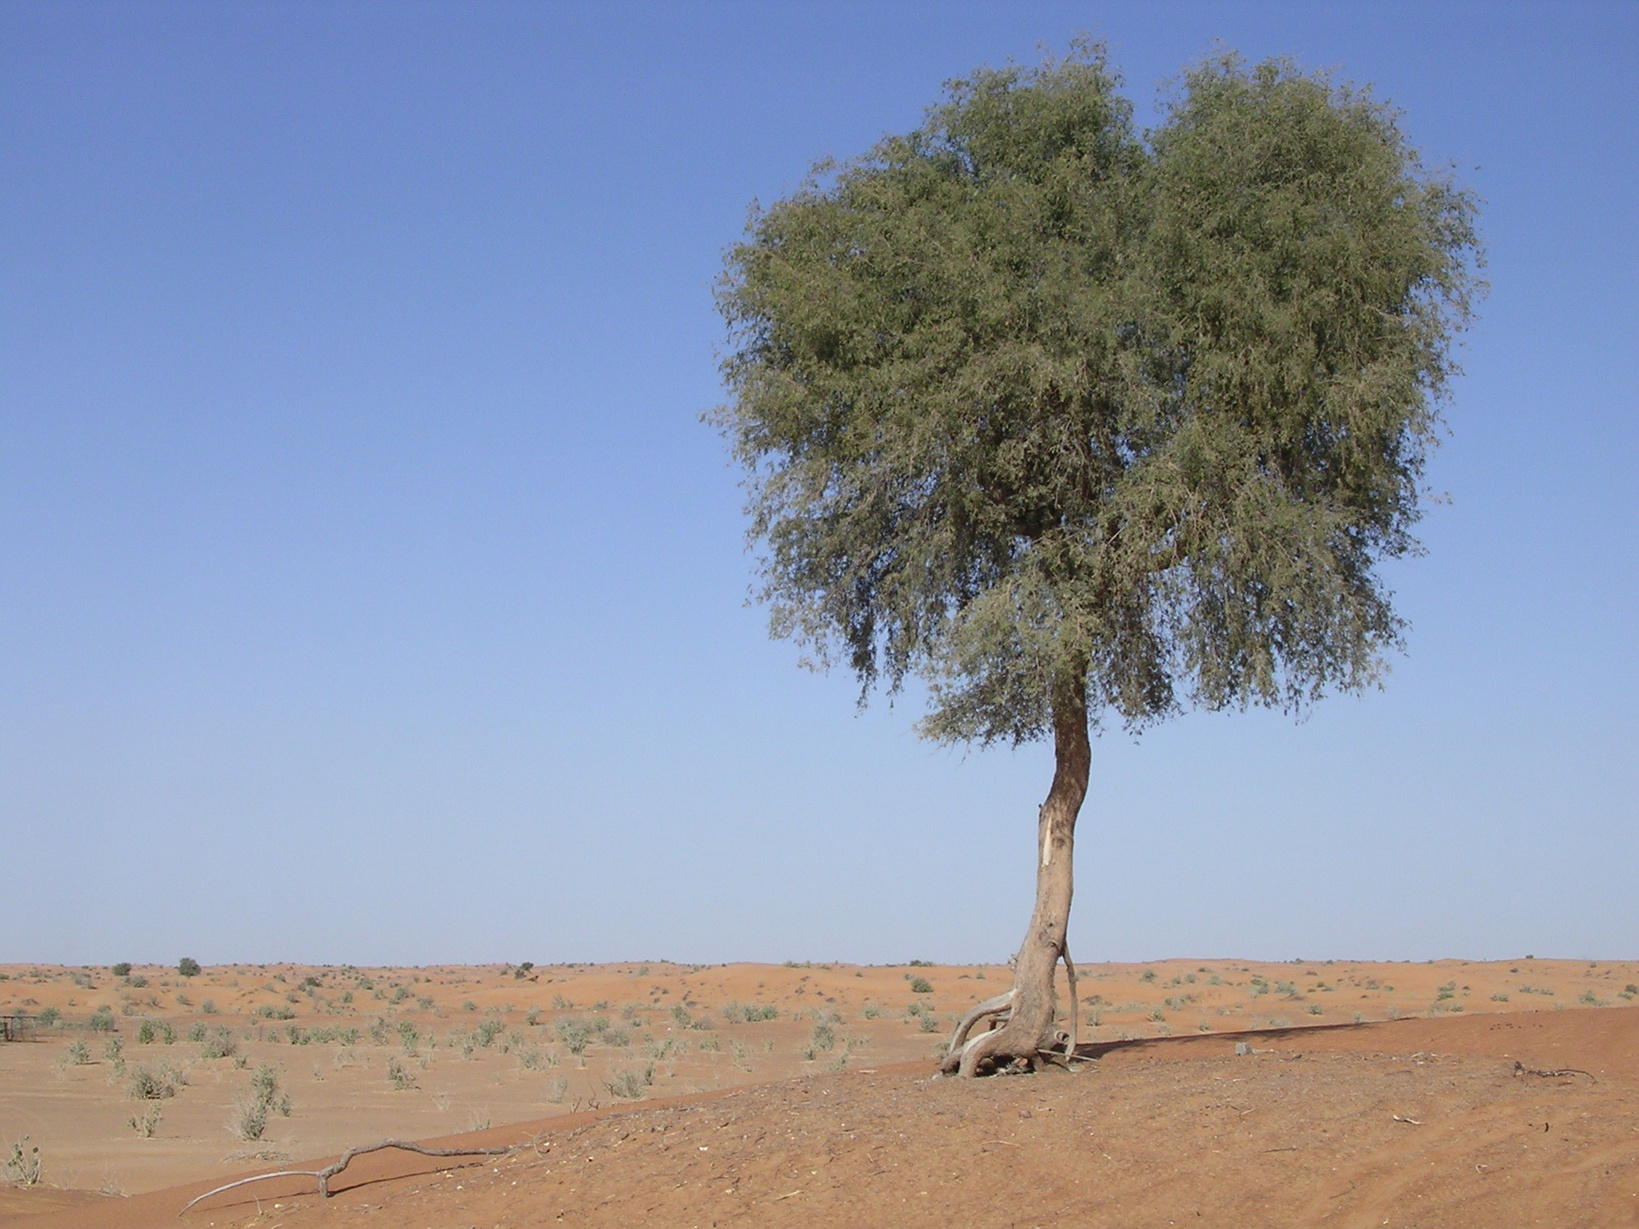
[0,0,1639,964]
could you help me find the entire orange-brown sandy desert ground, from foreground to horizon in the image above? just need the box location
[0,960,1639,1226]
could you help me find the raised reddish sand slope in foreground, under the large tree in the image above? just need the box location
[7,1008,1639,1229]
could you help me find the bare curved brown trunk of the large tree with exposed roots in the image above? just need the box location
[944,670,1093,1075]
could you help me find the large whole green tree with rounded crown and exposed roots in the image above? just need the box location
[715,43,1480,1073]
